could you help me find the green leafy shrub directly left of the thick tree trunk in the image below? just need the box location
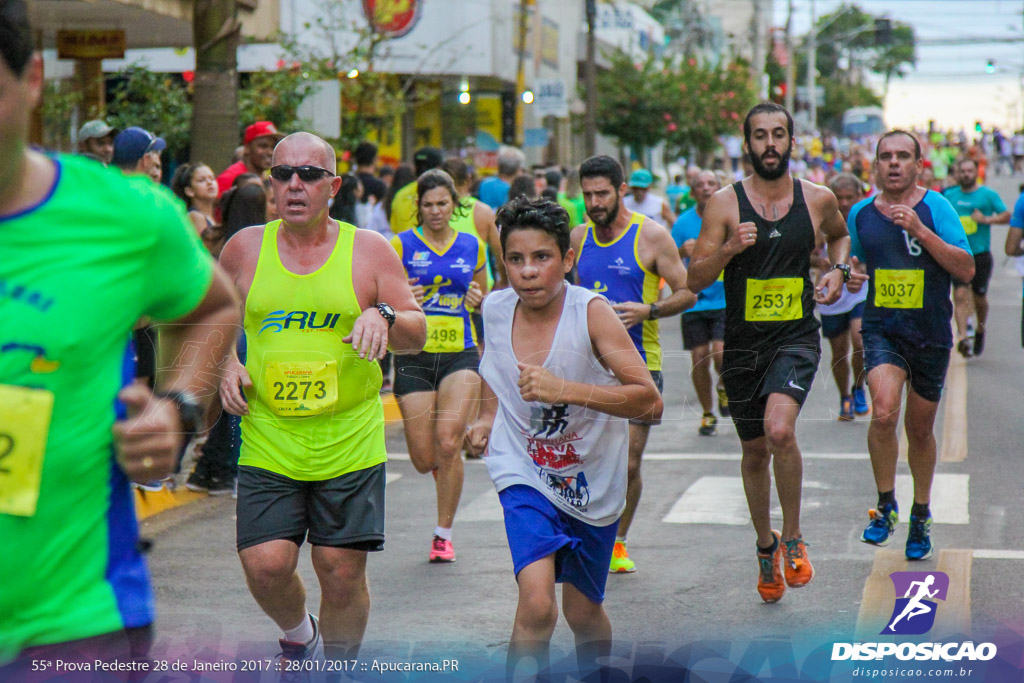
[106,63,191,159]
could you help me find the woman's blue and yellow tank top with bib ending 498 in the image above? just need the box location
[391,227,486,353]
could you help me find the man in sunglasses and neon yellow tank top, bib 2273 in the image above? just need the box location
[220,133,426,671]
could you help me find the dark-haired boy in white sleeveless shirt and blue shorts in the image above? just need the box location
[468,199,663,677]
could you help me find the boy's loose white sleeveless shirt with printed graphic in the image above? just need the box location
[480,283,629,526]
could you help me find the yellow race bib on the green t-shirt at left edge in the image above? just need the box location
[0,384,53,517]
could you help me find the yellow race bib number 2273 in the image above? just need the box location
[266,360,338,418]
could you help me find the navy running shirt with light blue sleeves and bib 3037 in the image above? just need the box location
[847,190,971,348]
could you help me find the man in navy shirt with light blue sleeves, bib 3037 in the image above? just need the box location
[849,130,975,560]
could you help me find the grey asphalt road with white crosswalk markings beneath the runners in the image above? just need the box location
[143,181,1024,680]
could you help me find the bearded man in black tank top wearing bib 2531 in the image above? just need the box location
[688,102,861,602]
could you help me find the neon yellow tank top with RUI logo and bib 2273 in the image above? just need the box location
[239,220,387,481]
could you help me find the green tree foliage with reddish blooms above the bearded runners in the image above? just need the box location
[593,52,755,159]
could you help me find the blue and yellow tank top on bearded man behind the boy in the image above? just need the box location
[577,212,662,371]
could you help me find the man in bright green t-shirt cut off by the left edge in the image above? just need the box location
[0,0,240,681]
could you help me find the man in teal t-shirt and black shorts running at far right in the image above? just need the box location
[945,158,1010,358]
